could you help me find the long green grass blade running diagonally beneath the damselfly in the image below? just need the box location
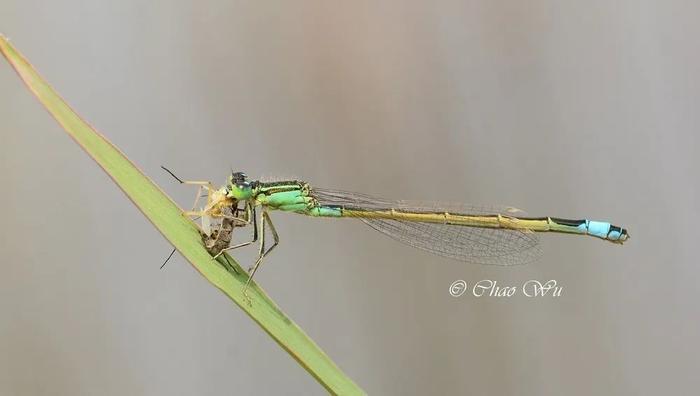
[0,35,364,394]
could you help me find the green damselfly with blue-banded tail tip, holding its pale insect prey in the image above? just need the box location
[163,168,629,300]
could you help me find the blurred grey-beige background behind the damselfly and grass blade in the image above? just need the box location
[0,0,700,395]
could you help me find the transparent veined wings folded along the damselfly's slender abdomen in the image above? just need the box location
[311,188,541,265]
